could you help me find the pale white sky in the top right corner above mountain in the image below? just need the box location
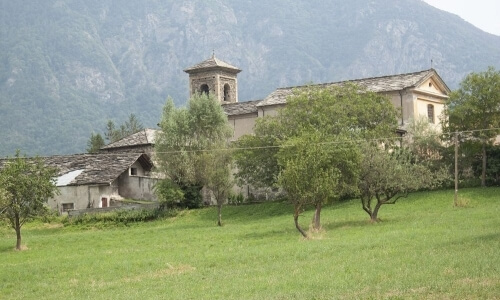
[424,0,500,36]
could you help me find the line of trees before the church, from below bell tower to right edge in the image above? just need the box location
[156,68,500,236]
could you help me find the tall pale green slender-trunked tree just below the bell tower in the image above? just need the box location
[155,94,232,225]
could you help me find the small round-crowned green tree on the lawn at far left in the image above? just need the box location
[0,151,58,250]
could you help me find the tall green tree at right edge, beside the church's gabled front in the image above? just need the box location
[443,67,500,186]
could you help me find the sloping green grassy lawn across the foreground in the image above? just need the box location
[0,188,500,299]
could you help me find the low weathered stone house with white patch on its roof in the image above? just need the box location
[42,153,156,213]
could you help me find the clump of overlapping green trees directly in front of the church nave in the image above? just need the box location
[232,84,445,237]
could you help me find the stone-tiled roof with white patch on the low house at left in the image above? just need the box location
[0,153,153,186]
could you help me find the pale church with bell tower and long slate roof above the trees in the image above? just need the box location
[184,55,451,140]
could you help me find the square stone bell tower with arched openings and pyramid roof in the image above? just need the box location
[184,53,241,103]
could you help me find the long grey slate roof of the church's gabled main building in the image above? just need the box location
[257,69,450,106]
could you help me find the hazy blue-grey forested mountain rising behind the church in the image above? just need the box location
[0,0,500,156]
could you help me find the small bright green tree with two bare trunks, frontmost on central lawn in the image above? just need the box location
[278,134,359,238]
